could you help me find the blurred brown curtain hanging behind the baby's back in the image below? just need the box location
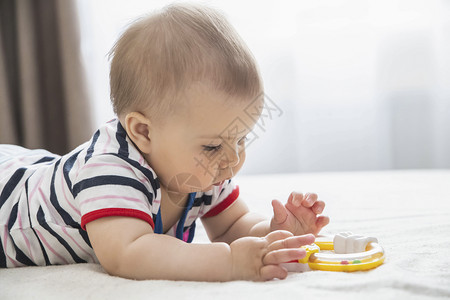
[0,0,93,154]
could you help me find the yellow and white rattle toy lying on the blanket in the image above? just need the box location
[282,232,384,272]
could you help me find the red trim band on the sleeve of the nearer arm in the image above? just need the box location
[81,208,155,230]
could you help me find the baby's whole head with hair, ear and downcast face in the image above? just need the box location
[110,5,263,193]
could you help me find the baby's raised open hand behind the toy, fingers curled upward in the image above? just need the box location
[270,192,330,235]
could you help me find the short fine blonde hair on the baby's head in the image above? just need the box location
[110,4,263,119]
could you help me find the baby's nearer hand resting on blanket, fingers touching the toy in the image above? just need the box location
[230,230,314,281]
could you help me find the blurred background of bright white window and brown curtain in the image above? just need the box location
[0,0,450,174]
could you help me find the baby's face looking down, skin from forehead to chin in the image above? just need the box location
[146,86,263,194]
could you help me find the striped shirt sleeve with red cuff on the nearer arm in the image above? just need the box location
[72,154,155,229]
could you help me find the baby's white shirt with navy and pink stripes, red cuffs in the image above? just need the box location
[0,119,239,267]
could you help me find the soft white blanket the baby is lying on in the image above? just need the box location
[0,170,450,300]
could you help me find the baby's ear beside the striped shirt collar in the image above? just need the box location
[124,112,151,154]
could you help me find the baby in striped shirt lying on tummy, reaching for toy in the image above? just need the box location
[0,4,329,281]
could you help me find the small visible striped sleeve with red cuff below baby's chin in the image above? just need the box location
[202,179,239,218]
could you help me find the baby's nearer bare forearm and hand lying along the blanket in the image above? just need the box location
[86,217,314,281]
